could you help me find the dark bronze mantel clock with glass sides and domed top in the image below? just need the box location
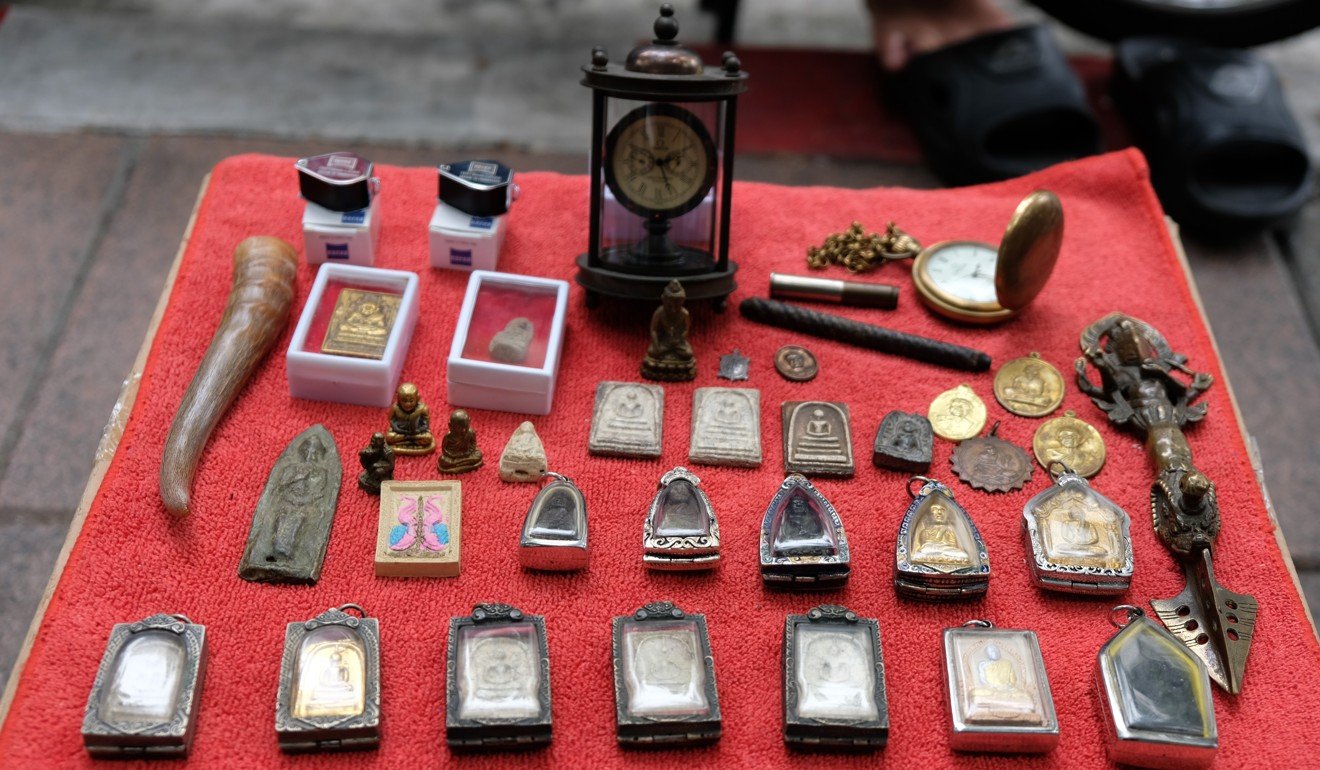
[577,3,747,309]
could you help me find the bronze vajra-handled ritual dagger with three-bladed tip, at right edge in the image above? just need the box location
[1077,313,1257,695]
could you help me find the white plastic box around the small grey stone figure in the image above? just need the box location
[445,269,569,415]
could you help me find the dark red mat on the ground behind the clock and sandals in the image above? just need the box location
[694,45,1131,164]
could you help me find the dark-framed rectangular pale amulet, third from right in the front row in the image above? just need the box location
[784,605,890,750]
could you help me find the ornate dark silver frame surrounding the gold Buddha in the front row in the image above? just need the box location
[275,605,380,754]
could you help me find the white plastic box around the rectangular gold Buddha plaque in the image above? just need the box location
[285,264,417,407]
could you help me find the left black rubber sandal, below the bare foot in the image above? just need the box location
[894,25,1100,185]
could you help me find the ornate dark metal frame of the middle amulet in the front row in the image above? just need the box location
[614,601,723,746]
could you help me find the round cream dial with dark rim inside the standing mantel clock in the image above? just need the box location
[605,102,715,218]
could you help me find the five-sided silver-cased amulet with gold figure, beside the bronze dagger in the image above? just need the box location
[1022,464,1133,594]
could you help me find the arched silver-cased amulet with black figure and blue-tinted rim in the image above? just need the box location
[760,473,853,590]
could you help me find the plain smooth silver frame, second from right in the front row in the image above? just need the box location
[944,621,1059,753]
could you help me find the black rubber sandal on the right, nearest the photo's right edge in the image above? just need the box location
[1114,37,1312,234]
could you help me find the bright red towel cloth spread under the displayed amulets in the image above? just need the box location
[0,152,1320,767]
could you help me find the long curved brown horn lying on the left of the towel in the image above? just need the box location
[160,235,298,516]
